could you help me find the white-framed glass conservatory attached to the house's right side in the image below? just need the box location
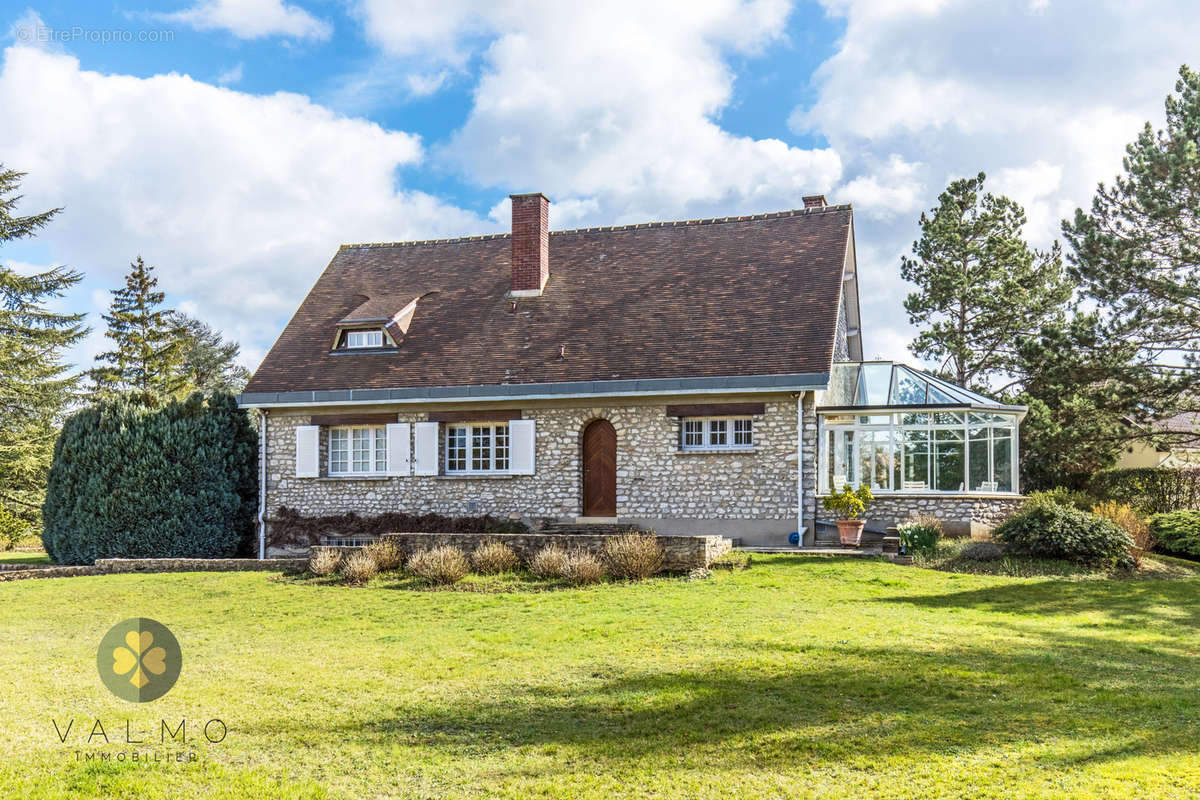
[817,361,1026,494]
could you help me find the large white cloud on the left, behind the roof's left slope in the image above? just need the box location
[0,47,496,366]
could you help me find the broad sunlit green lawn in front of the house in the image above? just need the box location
[0,557,1200,799]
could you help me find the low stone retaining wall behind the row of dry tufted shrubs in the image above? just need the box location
[311,534,732,572]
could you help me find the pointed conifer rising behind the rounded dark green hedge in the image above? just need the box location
[90,255,188,407]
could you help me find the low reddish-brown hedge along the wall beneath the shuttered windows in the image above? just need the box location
[266,506,529,547]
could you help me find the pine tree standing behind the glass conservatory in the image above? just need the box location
[900,173,1072,387]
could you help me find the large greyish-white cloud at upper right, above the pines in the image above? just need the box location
[791,0,1200,367]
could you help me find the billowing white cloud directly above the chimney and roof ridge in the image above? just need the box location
[360,0,841,227]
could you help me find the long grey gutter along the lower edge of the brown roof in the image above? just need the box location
[238,372,829,408]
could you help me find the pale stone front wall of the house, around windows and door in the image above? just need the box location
[266,392,817,551]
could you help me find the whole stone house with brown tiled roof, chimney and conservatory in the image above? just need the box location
[240,194,1024,554]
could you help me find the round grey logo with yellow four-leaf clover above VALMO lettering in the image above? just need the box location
[96,616,182,703]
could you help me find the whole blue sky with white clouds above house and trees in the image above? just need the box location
[0,0,1200,367]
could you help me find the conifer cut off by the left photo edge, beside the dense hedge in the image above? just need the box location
[0,166,88,522]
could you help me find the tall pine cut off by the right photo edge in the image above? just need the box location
[1062,66,1200,402]
